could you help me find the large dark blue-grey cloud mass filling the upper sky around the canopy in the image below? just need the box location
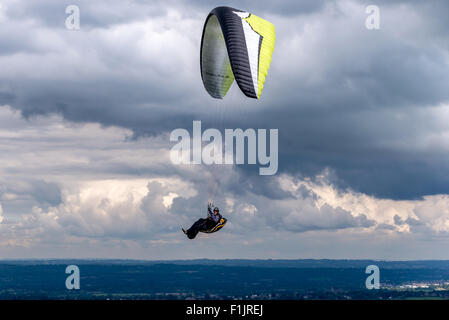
[0,0,449,199]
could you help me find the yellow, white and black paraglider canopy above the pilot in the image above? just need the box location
[200,7,276,99]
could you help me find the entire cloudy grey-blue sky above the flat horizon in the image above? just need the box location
[0,0,449,260]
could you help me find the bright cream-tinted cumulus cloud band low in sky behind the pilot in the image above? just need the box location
[0,107,449,258]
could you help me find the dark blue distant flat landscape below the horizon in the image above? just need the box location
[0,259,449,300]
